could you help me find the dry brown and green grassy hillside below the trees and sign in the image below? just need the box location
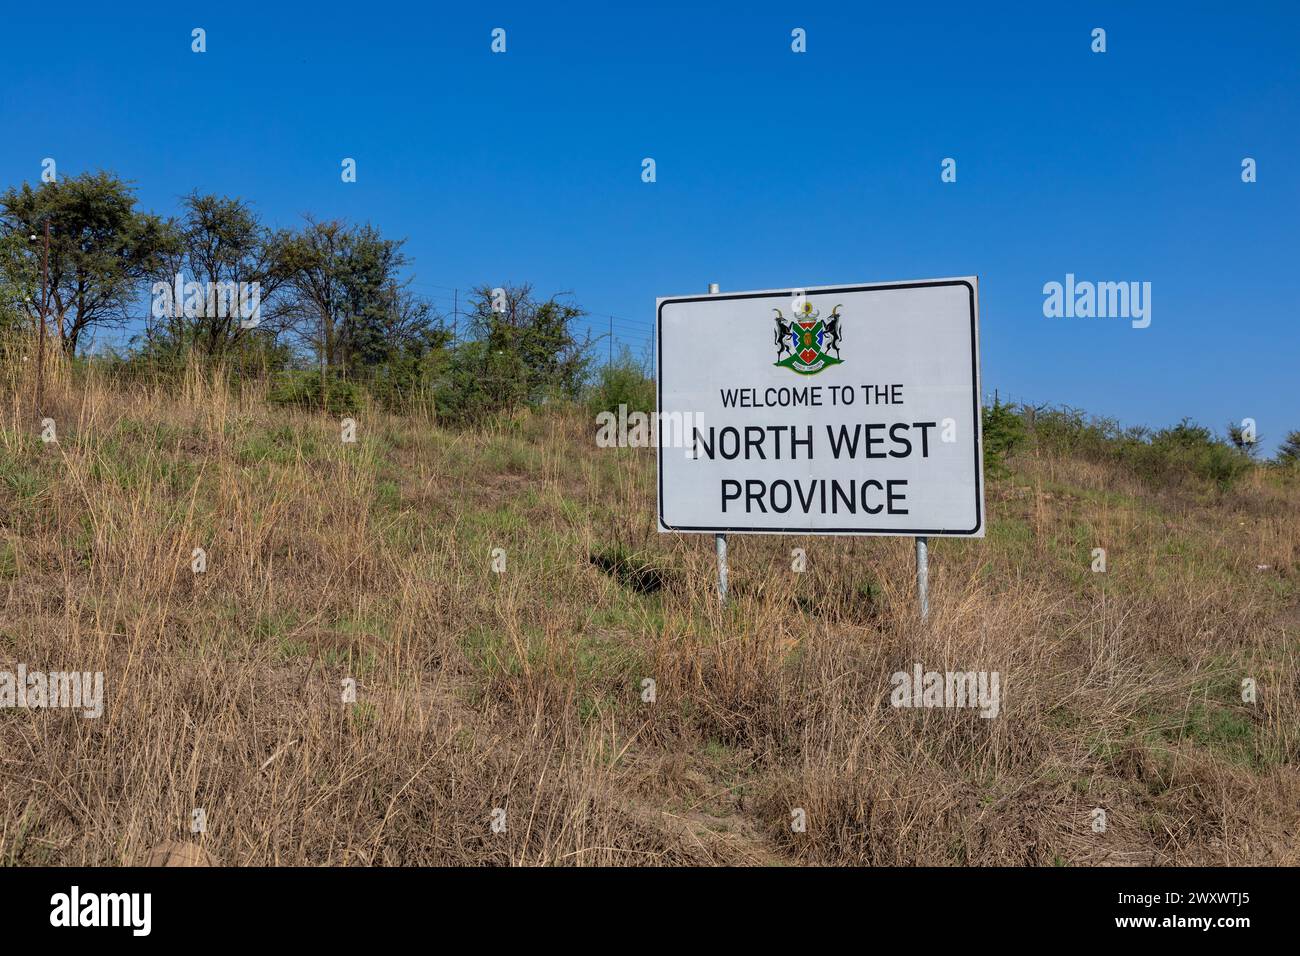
[0,361,1300,865]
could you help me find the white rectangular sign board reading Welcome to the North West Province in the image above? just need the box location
[655,277,984,537]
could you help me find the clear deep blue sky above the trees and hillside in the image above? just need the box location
[0,3,1300,450]
